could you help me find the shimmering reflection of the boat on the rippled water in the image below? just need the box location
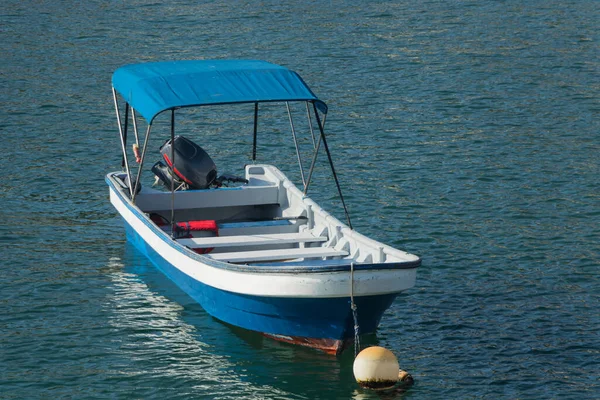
[105,243,364,398]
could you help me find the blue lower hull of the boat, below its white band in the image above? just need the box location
[125,222,397,353]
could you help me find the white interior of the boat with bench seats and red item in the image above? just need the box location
[113,165,413,266]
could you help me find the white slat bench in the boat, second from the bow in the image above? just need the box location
[178,232,327,249]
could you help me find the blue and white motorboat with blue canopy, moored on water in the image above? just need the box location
[106,60,421,354]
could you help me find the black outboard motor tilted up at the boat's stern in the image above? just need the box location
[152,136,217,189]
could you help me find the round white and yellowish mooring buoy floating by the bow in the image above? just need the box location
[352,346,404,390]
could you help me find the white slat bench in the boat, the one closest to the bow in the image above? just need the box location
[206,247,348,262]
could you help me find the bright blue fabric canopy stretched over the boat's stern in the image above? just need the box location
[112,60,327,123]
